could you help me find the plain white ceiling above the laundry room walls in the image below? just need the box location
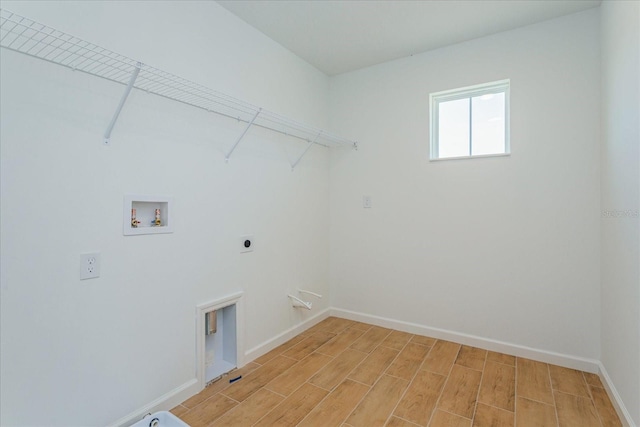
[218,0,600,75]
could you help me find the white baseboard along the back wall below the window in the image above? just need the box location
[331,308,600,374]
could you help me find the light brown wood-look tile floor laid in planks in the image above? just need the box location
[172,317,622,427]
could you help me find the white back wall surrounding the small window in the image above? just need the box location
[330,10,600,359]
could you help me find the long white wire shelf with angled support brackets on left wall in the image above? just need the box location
[0,9,357,155]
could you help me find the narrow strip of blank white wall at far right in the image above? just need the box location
[601,1,640,425]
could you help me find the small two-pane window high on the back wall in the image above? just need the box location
[429,80,509,160]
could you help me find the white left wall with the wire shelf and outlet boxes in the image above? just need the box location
[0,2,336,426]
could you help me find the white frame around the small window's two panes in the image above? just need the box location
[429,79,511,161]
